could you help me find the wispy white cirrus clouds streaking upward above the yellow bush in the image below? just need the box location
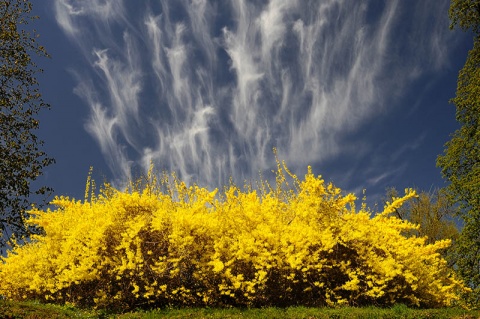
[54,0,456,192]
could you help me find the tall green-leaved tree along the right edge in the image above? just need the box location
[437,0,480,302]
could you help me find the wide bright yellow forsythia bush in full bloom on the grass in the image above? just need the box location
[0,163,465,309]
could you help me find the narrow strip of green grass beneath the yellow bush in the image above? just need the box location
[0,301,480,319]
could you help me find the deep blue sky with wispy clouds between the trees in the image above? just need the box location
[34,0,472,208]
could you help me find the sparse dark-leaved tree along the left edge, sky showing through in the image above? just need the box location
[0,0,54,254]
